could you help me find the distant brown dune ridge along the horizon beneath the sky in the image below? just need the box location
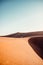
[2,31,43,38]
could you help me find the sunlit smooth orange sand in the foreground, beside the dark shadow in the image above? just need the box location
[0,37,43,65]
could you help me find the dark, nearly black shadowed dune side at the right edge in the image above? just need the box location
[28,37,43,59]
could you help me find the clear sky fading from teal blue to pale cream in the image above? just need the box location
[0,0,43,35]
